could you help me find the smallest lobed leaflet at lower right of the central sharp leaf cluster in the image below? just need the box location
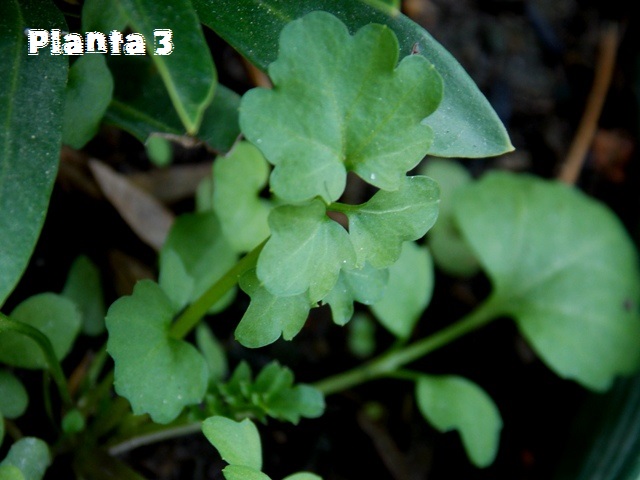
[322,263,389,325]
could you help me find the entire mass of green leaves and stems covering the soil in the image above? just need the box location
[0,0,640,480]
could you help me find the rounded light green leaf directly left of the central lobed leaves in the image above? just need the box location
[213,142,271,252]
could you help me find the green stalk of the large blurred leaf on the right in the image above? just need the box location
[313,297,501,395]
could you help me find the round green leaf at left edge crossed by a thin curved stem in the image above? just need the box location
[0,293,82,368]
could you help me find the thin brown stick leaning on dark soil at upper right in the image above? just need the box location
[558,23,619,185]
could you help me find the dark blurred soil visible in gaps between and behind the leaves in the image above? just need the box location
[7,0,640,480]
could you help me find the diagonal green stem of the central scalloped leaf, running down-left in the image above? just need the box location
[169,240,267,339]
